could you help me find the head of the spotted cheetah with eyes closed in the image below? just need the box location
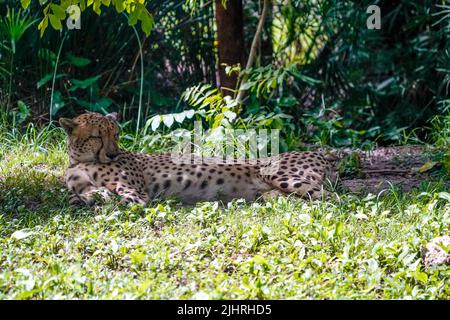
[59,112,120,164]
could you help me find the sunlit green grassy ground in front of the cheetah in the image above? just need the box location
[0,125,450,299]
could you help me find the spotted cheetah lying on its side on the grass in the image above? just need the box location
[59,112,329,205]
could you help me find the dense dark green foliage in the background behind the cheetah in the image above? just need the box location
[0,0,450,149]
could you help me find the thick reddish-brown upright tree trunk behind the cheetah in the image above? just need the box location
[215,0,245,94]
